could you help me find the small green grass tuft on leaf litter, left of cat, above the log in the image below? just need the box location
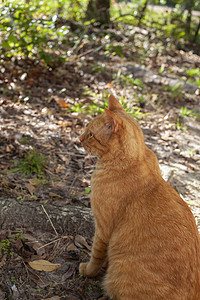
[8,148,46,177]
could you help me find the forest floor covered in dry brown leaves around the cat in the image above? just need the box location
[0,25,200,300]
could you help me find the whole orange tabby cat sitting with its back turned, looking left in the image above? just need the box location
[79,95,200,300]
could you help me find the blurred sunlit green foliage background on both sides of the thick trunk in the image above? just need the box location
[0,0,200,66]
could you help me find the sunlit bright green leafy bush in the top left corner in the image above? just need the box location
[0,1,69,64]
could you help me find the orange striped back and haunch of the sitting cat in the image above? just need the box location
[105,180,200,300]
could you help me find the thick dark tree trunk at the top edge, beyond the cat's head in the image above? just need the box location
[86,0,110,25]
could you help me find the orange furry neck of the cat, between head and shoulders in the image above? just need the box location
[92,147,162,198]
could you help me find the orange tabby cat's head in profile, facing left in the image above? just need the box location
[80,95,144,160]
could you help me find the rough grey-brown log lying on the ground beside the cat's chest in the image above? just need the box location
[0,198,94,237]
